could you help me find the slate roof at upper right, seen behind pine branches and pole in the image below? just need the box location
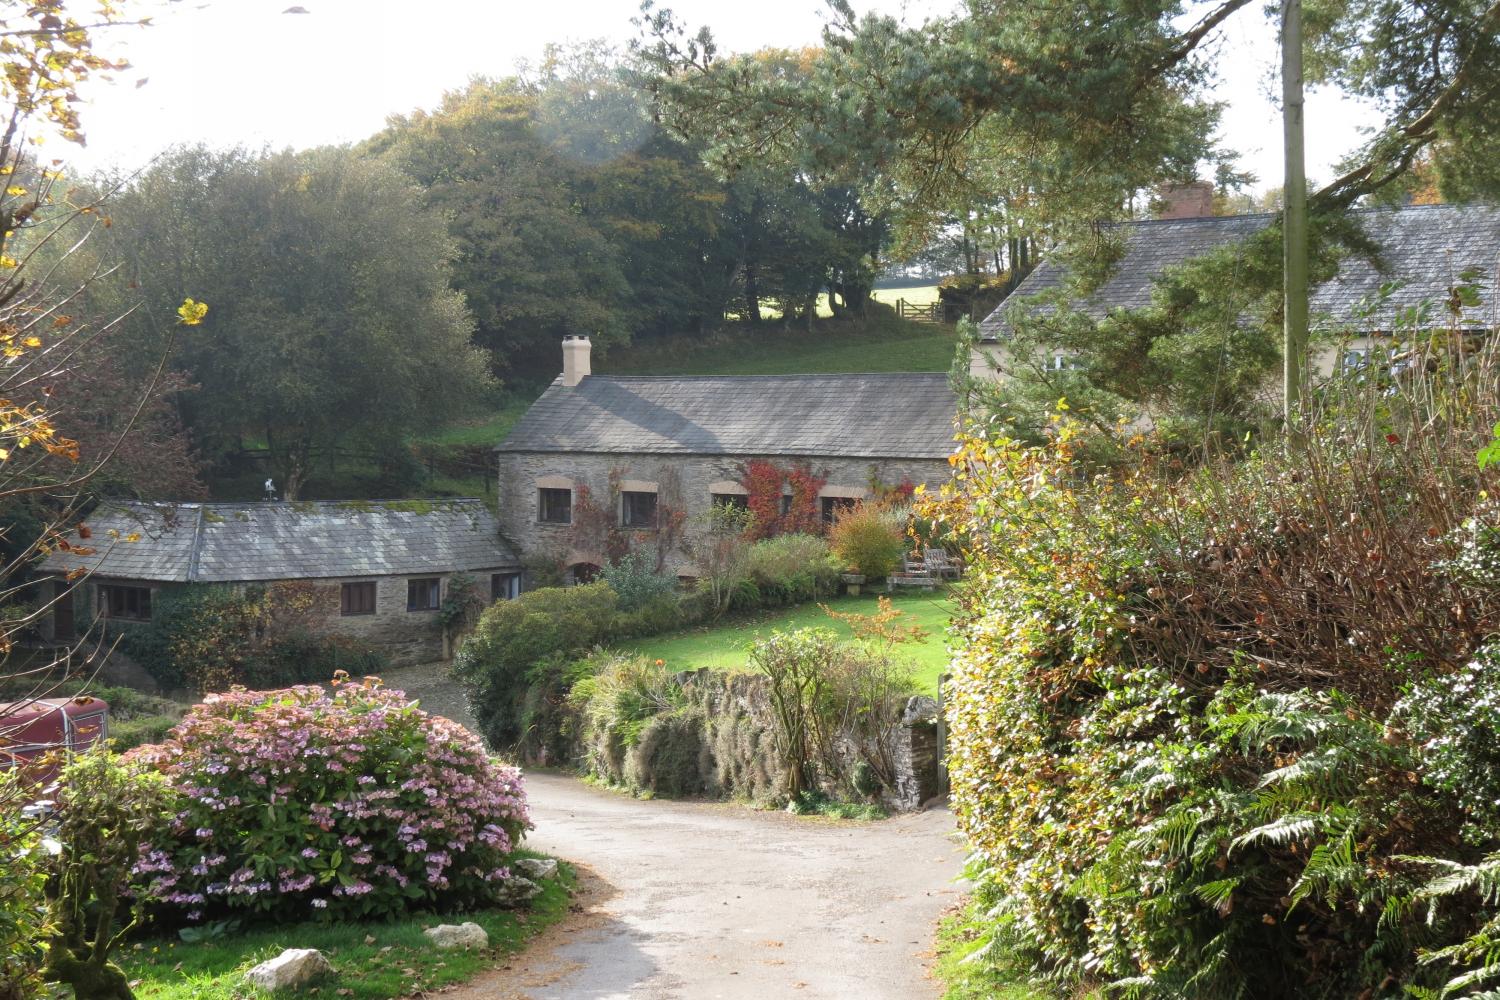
[980,205,1500,340]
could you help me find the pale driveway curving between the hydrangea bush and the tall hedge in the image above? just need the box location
[387,659,963,1000]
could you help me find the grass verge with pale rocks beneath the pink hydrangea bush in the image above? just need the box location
[122,852,576,1000]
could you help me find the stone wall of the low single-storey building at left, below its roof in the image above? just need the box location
[44,565,516,666]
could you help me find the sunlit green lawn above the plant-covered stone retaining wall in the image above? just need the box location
[621,591,954,696]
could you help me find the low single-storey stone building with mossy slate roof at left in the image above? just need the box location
[41,499,521,664]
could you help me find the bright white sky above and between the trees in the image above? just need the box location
[67,0,1374,197]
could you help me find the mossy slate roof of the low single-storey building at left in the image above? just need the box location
[41,499,516,583]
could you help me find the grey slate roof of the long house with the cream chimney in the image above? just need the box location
[497,372,959,459]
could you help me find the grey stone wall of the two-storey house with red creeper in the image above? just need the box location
[498,451,950,576]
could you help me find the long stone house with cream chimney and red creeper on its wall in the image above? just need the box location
[497,337,957,582]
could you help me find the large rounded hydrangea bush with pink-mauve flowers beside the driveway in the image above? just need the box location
[135,681,530,921]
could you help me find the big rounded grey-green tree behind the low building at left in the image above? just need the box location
[98,147,491,499]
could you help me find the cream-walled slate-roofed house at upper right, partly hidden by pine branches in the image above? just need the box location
[971,199,1500,379]
